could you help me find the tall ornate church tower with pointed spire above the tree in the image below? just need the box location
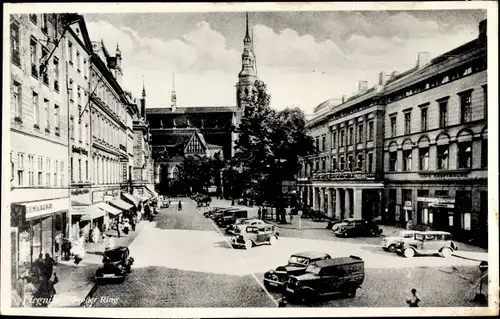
[236,12,257,110]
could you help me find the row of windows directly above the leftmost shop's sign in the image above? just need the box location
[10,152,64,187]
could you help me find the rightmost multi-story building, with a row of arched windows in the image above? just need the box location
[384,21,488,245]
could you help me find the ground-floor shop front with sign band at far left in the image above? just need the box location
[11,198,70,278]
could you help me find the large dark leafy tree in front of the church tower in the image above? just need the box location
[230,80,314,221]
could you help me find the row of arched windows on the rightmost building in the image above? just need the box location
[389,139,488,172]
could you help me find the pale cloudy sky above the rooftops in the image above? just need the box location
[84,10,486,114]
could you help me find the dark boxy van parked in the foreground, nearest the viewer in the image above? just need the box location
[283,256,365,302]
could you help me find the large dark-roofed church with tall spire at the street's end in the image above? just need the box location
[146,14,257,193]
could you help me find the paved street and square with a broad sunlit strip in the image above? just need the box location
[90,199,488,307]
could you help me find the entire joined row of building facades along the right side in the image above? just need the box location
[298,20,488,242]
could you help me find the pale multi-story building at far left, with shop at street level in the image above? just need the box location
[9,14,74,288]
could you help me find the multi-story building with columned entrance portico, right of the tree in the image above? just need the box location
[298,79,385,219]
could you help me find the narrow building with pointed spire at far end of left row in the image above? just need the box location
[132,86,158,198]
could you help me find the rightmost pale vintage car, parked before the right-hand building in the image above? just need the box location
[396,231,458,258]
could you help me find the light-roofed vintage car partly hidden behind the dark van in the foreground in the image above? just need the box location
[264,251,332,290]
